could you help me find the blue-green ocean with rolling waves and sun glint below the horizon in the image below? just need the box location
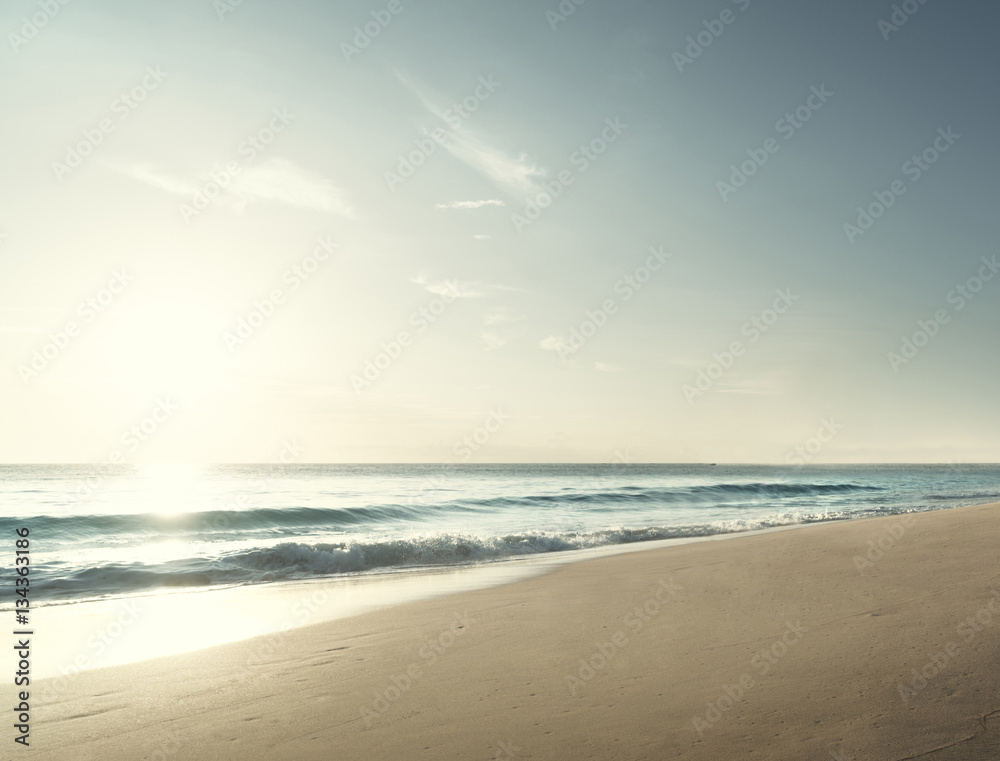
[0,464,1000,607]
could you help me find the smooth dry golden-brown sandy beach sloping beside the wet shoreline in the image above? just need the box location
[31,504,1000,761]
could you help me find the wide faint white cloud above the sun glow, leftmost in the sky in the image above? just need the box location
[119,157,355,217]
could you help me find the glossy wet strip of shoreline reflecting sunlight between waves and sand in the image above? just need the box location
[19,498,972,679]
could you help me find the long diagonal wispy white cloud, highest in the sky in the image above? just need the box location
[395,70,547,195]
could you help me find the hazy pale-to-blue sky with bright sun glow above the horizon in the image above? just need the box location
[0,0,1000,464]
